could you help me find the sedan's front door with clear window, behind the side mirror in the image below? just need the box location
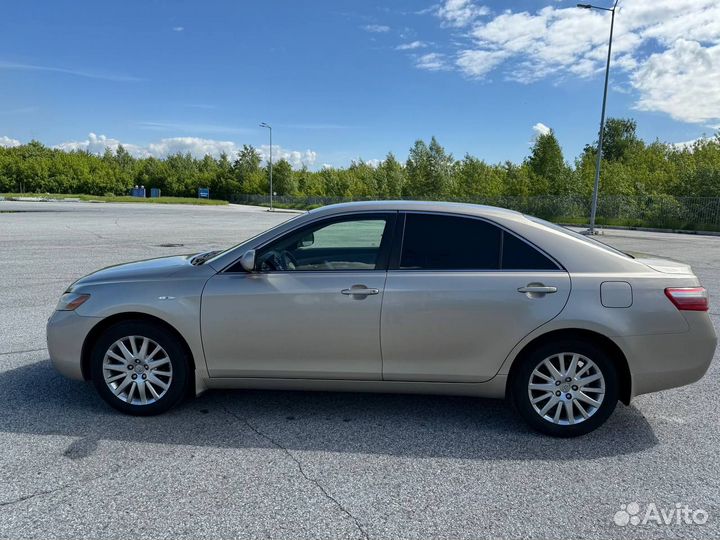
[201,213,397,380]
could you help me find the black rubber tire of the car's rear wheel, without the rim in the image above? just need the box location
[510,339,618,437]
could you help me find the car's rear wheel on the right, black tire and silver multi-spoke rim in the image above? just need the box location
[510,340,618,437]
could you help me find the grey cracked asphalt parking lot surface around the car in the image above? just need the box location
[0,202,720,540]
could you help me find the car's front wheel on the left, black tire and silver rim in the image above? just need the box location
[91,321,189,416]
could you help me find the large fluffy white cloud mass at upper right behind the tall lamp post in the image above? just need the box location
[416,0,720,123]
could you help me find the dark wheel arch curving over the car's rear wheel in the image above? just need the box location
[506,328,632,405]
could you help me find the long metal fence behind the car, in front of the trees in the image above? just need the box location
[232,194,720,231]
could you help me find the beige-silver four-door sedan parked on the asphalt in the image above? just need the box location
[47,202,717,436]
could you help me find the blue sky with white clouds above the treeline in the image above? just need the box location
[0,0,720,168]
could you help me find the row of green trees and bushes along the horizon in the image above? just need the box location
[0,118,720,200]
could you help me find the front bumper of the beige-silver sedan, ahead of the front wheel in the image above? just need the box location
[47,311,101,380]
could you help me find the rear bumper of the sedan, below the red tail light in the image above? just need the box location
[615,311,717,397]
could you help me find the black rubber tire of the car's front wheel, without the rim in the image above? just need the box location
[90,321,191,416]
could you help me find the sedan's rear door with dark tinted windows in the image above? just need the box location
[381,213,570,382]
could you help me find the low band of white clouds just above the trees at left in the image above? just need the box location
[50,133,317,167]
